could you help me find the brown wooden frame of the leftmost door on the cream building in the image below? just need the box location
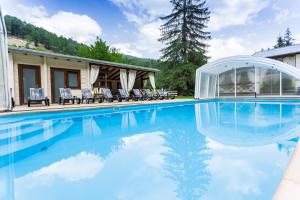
[18,64,41,105]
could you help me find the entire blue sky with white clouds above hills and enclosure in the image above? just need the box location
[0,0,300,60]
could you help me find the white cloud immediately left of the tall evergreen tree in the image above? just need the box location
[111,0,171,58]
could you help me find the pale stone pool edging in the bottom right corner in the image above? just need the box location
[273,143,300,200]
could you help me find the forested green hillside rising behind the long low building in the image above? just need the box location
[5,15,158,67]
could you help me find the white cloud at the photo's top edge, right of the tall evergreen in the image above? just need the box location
[208,0,268,31]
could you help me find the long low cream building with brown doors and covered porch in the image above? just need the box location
[9,47,159,105]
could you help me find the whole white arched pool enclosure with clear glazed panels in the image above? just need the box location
[195,56,300,99]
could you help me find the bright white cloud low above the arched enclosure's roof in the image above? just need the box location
[208,37,253,60]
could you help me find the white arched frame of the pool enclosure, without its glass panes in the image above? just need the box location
[195,56,300,99]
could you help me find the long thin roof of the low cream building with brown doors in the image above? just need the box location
[8,46,160,72]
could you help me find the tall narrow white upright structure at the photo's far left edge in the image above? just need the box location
[0,8,12,111]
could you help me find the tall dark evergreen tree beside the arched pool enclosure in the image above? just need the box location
[157,0,211,95]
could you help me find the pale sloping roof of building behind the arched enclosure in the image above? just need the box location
[253,44,300,58]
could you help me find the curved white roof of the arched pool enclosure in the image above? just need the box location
[197,56,300,79]
